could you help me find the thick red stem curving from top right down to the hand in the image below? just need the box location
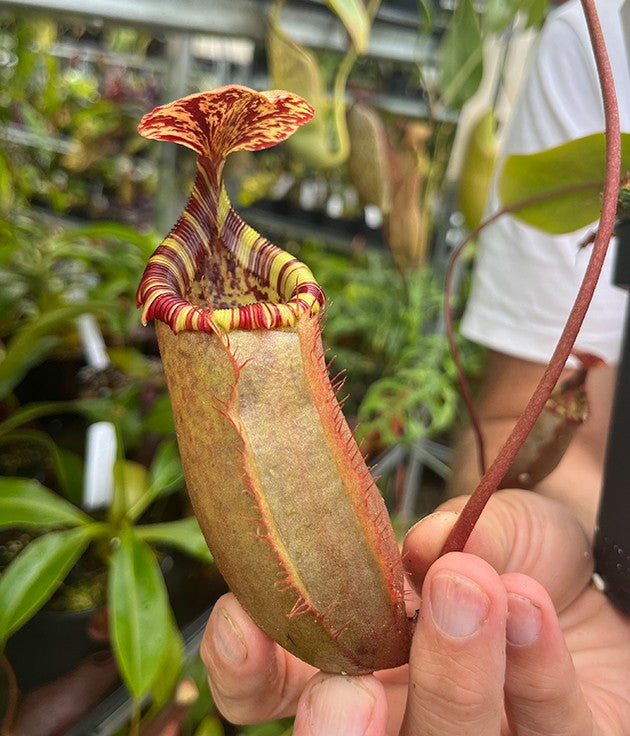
[442,0,621,554]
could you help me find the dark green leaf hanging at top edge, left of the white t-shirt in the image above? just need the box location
[440,0,483,108]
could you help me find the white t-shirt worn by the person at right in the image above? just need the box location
[461,0,630,363]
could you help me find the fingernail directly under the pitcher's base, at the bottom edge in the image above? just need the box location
[309,676,374,736]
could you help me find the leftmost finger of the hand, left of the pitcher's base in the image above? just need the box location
[201,593,316,723]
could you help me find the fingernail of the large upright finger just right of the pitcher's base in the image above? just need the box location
[429,572,490,638]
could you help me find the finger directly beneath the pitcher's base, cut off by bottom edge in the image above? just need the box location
[293,673,387,736]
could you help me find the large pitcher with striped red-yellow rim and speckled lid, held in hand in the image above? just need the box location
[138,86,410,673]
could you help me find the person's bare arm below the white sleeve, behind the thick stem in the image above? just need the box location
[449,351,616,535]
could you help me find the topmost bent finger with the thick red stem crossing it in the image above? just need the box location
[403,490,593,610]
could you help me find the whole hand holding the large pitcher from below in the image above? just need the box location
[202,491,630,736]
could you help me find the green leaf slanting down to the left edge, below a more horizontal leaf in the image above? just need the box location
[0,524,103,648]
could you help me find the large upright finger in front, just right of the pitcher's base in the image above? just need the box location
[401,553,507,736]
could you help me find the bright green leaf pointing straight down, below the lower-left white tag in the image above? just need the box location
[109,528,171,700]
